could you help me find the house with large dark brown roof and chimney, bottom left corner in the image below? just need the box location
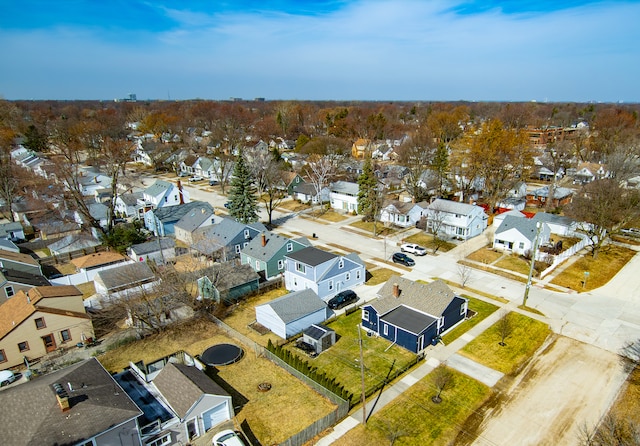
[0,358,142,446]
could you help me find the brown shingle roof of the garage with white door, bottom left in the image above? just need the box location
[153,362,229,418]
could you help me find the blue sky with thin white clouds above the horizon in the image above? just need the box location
[0,0,640,102]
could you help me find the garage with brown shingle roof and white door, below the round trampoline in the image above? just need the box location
[151,362,235,445]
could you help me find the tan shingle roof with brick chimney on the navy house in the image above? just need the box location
[371,276,456,317]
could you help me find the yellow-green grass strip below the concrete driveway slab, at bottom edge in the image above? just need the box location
[334,370,491,446]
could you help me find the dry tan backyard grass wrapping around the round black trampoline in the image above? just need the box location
[98,319,334,444]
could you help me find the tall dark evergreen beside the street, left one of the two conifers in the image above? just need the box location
[229,152,258,224]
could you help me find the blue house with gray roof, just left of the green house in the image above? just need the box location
[191,217,267,262]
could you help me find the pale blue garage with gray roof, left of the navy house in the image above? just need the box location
[256,289,329,339]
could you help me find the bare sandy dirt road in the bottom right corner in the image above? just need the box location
[464,337,626,446]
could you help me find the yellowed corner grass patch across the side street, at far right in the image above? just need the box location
[551,245,636,291]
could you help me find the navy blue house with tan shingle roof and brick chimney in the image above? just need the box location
[362,276,468,354]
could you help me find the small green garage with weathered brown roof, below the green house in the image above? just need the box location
[197,262,260,304]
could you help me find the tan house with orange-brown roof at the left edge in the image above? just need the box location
[0,285,93,369]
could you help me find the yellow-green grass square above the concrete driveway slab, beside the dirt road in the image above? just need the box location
[460,312,551,375]
